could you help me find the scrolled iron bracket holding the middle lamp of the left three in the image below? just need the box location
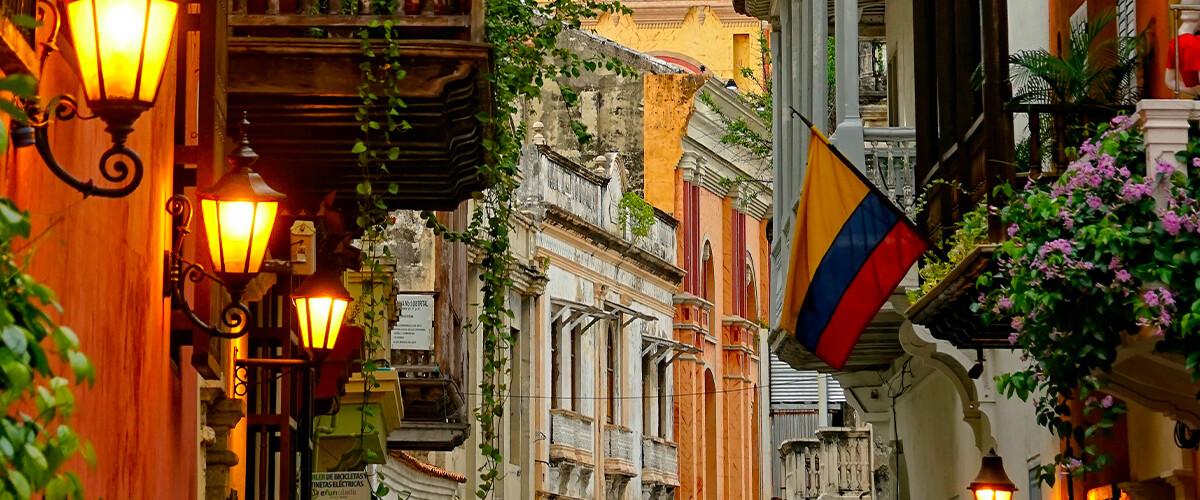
[164,194,253,338]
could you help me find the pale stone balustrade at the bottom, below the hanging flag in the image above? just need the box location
[779,427,875,500]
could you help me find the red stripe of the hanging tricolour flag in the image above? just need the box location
[814,223,926,371]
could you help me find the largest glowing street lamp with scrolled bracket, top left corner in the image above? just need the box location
[14,0,179,198]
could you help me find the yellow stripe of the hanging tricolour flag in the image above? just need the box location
[780,128,870,335]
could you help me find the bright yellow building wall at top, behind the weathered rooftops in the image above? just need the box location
[586,1,763,92]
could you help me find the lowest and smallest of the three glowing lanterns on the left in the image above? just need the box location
[292,266,352,360]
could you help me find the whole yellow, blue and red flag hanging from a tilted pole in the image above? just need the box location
[781,127,929,369]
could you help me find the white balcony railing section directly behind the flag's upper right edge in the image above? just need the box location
[863,127,917,217]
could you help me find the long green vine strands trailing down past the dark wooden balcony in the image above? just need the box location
[340,0,633,499]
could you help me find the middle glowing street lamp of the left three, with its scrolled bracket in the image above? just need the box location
[167,118,284,338]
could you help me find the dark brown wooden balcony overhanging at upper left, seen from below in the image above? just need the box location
[224,0,490,210]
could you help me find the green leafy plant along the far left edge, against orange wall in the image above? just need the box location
[0,62,96,500]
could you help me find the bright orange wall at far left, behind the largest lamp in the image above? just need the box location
[0,30,197,500]
